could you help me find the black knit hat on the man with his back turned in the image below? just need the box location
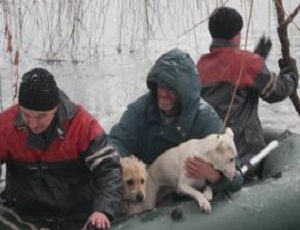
[208,7,243,40]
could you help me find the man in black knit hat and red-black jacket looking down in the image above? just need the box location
[0,68,122,230]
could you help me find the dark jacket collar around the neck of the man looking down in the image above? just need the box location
[15,90,76,149]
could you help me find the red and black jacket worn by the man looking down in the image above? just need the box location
[0,92,122,217]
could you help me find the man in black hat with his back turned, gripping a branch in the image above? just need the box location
[197,7,298,176]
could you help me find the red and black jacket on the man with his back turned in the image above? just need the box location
[197,39,295,163]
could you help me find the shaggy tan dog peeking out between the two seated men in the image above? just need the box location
[121,156,148,215]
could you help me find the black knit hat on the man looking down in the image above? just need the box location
[19,68,59,111]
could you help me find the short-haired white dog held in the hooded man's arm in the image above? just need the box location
[139,128,236,212]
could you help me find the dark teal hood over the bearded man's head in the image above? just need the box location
[147,49,200,115]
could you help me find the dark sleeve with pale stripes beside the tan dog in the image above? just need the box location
[85,135,123,219]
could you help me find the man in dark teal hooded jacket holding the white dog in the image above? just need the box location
[109,49,243,196]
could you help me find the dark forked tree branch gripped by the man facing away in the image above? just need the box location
[274,0,300,116]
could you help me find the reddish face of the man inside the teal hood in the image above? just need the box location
[157,86,179,116]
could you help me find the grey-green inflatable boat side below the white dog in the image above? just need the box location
[112,131,300,230]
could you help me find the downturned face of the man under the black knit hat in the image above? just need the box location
[20,106,57,134]
